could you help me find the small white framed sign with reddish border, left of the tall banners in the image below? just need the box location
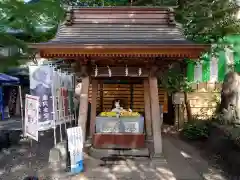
[24,94,39,141]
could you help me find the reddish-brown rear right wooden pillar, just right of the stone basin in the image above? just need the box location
[143,79,152,140]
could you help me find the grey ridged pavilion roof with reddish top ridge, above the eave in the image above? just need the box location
[40,7,191,45]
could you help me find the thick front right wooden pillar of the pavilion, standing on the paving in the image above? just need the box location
[149,76,163,157]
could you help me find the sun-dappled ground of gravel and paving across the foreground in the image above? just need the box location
[0,129,227,180]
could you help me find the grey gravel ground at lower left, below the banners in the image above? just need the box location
[0,131,61,180]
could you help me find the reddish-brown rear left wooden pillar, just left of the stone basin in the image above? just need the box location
[90,79,98,138]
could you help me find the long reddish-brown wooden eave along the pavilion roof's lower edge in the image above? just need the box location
[36,44,210,59]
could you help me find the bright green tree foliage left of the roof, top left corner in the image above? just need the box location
[0,0,64,71]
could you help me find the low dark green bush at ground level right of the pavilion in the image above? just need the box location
[181,119,210,140]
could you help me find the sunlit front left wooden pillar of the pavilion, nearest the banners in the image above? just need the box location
[78,76,89,141]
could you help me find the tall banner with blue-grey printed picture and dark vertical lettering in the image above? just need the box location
[29,65,54,131]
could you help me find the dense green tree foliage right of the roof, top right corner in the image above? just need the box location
[177,0,240,44]
